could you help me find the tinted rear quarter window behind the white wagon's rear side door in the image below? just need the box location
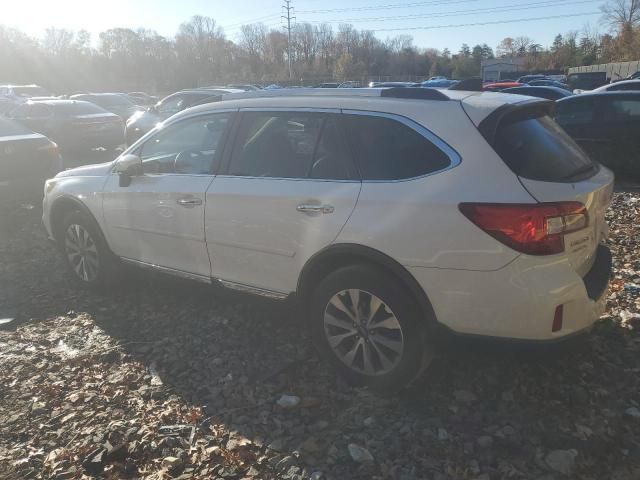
[344,114,451,180]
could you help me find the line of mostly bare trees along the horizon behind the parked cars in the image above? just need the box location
[0,0,640,93]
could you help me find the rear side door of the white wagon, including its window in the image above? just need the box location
[206,109,361,294]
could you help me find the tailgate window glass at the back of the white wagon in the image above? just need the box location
[494,116,596,182]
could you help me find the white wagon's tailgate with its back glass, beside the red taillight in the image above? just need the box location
[494,114,613,276]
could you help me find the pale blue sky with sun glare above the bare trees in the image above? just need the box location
[0,0,606,52]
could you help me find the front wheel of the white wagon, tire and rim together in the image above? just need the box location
[56,210,116,288]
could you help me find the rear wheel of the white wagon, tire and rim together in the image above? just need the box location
[310,265,433,389]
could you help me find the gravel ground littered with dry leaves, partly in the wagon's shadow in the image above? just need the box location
[0,193,640,480]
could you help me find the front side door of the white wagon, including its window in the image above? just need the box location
[103,113,232,279]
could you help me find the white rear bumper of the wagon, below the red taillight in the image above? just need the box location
[409,246,612,342]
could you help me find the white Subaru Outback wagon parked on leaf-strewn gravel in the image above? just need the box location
[43,88,613,387]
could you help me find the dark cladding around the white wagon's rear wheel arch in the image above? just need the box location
[297,243,437,323]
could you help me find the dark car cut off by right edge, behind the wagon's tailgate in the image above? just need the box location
[555,92,640,180]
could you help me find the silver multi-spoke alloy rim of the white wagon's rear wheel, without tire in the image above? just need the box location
[324,289,404,376]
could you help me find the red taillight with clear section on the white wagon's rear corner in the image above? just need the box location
[459,202,589,255]
